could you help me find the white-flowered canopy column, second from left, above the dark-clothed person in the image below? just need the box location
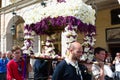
[38,34,60,58]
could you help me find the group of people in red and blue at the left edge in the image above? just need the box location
[0,46,32,80]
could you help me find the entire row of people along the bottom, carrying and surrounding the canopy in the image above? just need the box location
[0,42,120,80]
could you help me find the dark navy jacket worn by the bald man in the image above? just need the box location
[52,60,91,80]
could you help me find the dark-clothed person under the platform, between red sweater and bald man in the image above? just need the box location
[33,59,53,80]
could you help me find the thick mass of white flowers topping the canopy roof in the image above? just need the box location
[24,0,95,25]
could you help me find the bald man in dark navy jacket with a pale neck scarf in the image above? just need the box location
[52,42,90,80]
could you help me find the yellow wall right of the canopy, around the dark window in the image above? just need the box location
[95,6,120,49]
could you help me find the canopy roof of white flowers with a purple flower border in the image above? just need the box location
[25,0,95,35]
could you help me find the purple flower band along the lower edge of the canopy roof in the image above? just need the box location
[25,15,96,35]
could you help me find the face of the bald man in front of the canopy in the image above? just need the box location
[72,45,83,60]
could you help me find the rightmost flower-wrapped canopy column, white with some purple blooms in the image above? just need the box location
[81,32,96,61]
